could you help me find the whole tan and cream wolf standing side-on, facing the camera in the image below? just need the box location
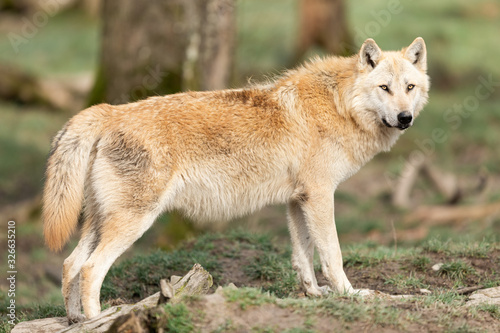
[42,37,430,322]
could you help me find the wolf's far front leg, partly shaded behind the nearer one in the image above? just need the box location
[288,202,328,296]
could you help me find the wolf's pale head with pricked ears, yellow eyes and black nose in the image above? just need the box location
[356,37,429,130]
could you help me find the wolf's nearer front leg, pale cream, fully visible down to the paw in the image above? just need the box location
[302,188,354,293]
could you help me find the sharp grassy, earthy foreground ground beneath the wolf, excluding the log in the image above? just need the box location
[4,230,500,332]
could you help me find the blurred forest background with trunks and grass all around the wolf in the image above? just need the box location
[0,0,500,304]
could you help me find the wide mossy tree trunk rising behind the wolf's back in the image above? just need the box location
[89,0,235,104]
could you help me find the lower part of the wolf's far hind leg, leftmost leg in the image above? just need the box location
[62,232,95,323]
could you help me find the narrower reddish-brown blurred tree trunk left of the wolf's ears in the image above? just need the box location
[295,0,354,61]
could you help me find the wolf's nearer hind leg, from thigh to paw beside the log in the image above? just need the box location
[80,213,156,318]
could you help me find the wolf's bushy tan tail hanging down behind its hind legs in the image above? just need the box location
[42,105,104,251]
